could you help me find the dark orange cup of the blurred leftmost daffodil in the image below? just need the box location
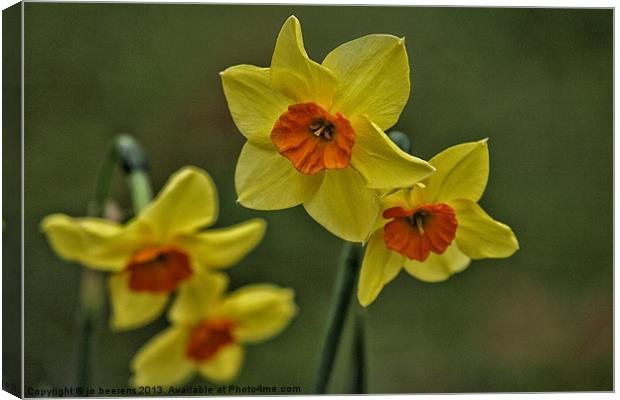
[125,246,192,292]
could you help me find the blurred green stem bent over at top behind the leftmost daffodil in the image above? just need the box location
[77,134,152,389]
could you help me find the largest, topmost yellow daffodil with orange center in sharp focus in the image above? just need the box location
[221,16,433,242]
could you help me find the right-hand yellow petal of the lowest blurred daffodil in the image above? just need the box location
[216,284,297,342]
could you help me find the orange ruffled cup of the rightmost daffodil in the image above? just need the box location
[383,203,458,261]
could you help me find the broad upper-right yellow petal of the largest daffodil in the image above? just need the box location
[323,35,410,129]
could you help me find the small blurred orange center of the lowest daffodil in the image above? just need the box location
[185,320,235,362]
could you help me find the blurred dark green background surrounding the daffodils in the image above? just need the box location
[25,3,613,393]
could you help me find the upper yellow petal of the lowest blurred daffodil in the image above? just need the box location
[168,272,228,325]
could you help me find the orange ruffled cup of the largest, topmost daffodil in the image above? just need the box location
[271,103,355,175]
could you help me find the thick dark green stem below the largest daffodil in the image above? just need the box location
[314,242,360,394]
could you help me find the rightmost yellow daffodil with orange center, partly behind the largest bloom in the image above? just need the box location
[358,140,519,306]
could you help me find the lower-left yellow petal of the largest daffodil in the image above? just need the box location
[235,142,323,210]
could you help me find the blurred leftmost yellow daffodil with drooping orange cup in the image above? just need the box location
[41,167,265,330]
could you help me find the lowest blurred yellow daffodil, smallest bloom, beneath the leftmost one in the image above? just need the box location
[131,275,296,386]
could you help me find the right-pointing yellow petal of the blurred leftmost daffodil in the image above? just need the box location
[174,218,266,268]
